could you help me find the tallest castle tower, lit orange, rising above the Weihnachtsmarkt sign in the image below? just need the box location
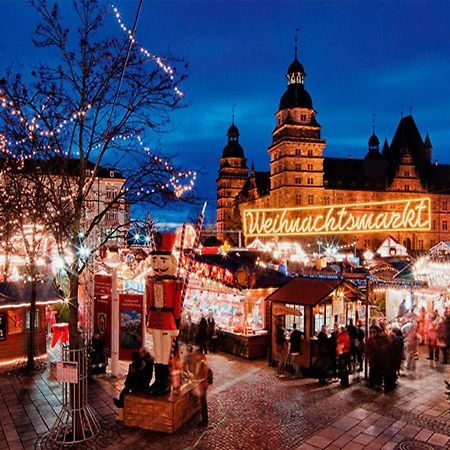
[268,46,325,207]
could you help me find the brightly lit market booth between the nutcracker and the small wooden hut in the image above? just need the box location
[183,252,289,359]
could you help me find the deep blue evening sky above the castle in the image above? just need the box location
[0,0,450,227]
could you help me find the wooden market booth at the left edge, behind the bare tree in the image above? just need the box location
[0,280,64,365]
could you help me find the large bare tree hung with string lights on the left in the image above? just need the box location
[1,0,192,348]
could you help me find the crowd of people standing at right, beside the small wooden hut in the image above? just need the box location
[315,308,450,392]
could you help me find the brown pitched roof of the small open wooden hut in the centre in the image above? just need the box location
[267,277,362,306]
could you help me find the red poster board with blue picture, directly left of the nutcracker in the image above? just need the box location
[119,292,144,360]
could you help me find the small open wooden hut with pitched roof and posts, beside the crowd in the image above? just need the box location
[266,275,365,369]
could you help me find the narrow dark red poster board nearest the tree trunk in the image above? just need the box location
[94,275,112,356]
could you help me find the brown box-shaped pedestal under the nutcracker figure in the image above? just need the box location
[123,385,201,433]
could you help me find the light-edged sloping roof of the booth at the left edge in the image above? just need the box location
[0,280,63,307]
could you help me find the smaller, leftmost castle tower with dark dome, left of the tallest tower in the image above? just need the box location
[216,121,248,241]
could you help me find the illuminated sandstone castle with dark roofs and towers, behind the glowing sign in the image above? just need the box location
[217,51,450,250]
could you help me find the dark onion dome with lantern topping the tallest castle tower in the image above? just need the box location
[279,55,313,110]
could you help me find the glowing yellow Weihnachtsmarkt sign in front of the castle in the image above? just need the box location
[244,198,431,237]
